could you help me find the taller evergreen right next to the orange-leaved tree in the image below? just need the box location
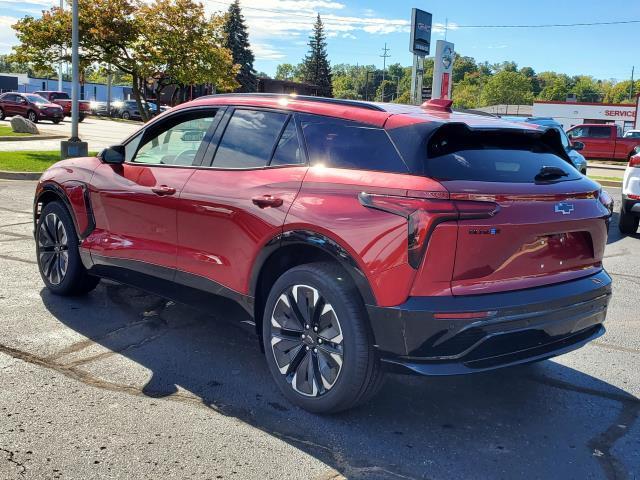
[224,0,258,92]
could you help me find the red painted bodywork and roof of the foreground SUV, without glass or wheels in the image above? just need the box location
[36,95,610,320]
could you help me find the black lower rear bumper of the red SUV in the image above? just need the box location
[367,270,611,375]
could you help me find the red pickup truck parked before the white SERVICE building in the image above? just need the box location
[567,123,640,160]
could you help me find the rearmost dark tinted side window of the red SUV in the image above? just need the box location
[302,122,408,173]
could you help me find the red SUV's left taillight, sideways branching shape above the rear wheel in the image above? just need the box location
[358,192,499,268]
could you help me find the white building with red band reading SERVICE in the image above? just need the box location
[533,97,640,131]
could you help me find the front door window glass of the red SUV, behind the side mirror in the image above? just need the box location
[133,112,215,165]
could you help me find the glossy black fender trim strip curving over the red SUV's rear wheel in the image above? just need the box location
[249,230,377,306]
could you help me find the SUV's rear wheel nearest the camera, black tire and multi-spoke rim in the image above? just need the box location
[262,263,383,413]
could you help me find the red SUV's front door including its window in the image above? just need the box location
[83,109,222,279]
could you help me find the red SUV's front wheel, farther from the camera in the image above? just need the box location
[36,202,100,296]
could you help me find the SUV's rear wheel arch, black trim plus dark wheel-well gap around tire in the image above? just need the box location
[249,230,377,338]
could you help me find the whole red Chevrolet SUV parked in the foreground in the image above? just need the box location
[34,94,612,412]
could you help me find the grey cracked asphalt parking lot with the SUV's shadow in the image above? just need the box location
[0,181,640,479]
